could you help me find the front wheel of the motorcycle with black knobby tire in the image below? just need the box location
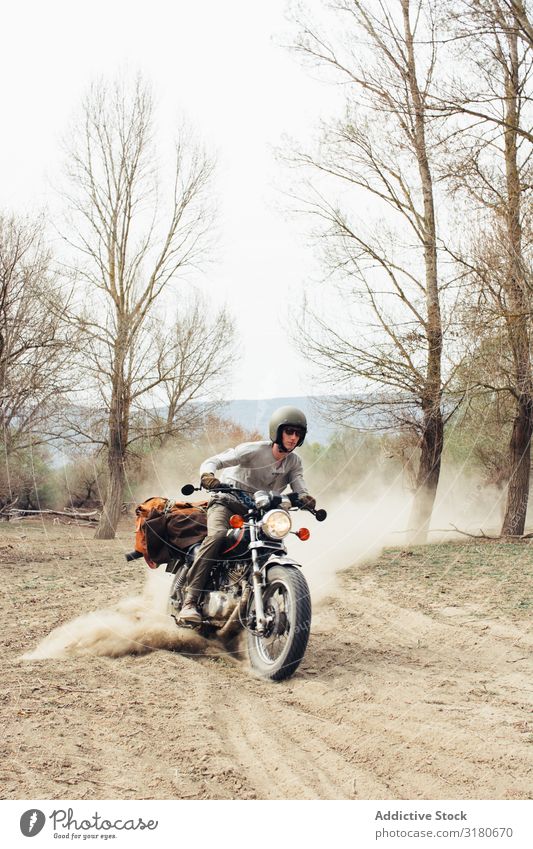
[248,566,311,681]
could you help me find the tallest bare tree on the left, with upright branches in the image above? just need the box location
[62,78,224,539]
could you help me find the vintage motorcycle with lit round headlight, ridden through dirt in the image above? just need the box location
[131,484,327,681]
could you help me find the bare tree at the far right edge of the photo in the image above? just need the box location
[438,0,533,535]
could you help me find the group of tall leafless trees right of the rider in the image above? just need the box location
[288,0,533,542]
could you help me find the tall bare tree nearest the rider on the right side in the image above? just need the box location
[295,0,454,541]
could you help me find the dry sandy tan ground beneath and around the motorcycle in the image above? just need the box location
[0,522,533,799]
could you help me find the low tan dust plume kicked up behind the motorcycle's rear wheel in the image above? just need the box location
[23,571,209,660]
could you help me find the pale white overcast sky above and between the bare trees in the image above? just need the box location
[0,0,340,398]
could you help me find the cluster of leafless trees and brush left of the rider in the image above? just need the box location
[0,77,233,539]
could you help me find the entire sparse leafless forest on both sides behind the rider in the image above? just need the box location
[0,0,533,542]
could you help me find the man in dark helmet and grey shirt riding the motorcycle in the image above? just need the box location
[180,407,316,624]
